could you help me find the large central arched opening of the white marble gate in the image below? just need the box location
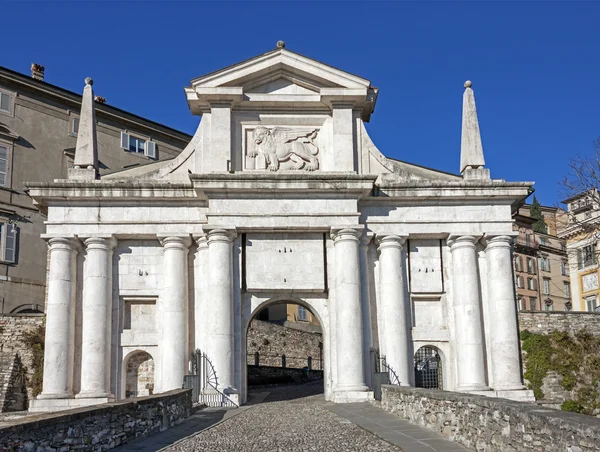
[246,300,324,400]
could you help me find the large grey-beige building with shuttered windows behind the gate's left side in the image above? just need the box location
[0,65,191,314]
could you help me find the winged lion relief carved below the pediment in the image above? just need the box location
[247,126,319,171]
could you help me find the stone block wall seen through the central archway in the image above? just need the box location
[247,320,323,370]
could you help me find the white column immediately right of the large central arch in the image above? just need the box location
[333,229,368,391]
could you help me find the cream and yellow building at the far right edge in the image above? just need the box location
[559,190,600,312]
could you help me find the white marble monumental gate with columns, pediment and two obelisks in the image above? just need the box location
[29,42,531,411]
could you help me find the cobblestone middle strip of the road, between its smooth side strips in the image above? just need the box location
[163,382,401,452]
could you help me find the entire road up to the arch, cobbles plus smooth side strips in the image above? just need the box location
[117,383,466,452]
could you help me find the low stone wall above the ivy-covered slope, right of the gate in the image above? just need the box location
[519,311,600,336]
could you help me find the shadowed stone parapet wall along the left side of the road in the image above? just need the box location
[0,389,192,451]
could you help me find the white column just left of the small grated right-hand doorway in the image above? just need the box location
[378,235,414,386]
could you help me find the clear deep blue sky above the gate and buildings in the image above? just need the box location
[0,1,600,205]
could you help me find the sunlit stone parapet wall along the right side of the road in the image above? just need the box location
[381,385,600,452]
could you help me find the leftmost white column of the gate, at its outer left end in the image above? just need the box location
[37,238,77,399]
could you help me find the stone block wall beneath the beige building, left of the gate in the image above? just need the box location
[0,314,45,412]
